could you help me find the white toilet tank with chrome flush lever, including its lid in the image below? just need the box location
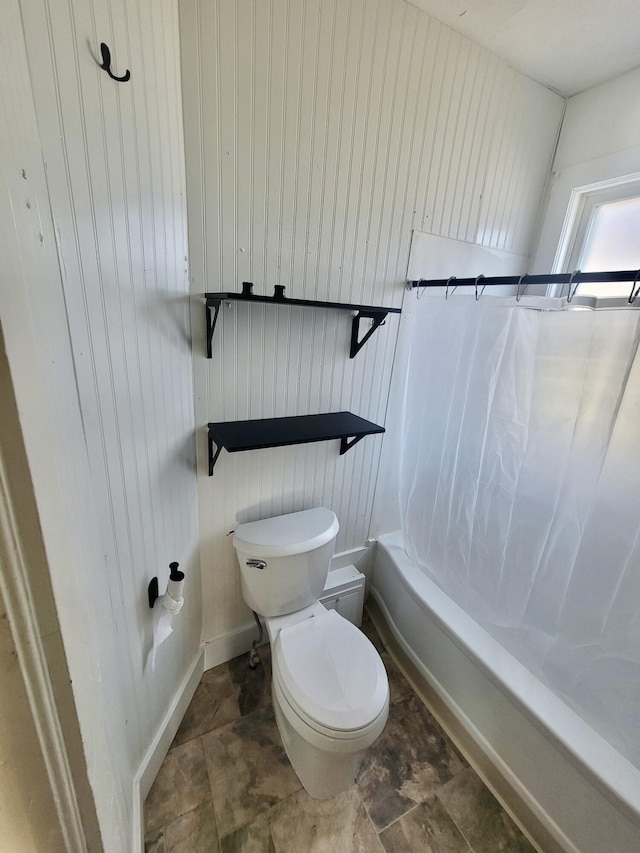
[233,507,339,616]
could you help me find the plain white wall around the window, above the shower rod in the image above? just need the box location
[532,68,640,272]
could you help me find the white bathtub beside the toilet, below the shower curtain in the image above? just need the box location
[369,533,640,853]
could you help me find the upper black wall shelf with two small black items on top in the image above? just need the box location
[204,281,401,358]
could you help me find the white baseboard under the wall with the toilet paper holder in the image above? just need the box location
[132,649,205,851]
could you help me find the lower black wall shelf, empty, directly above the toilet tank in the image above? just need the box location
[209,412,384,476]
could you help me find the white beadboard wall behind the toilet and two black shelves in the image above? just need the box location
[180,0,562,640]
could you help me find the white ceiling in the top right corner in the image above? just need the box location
[410,0,640,97]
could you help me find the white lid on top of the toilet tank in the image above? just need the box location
[233,506,340,557]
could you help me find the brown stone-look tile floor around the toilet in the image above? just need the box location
[145,618,534,853]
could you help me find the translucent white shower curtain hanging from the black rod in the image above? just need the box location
[399,294,640,766]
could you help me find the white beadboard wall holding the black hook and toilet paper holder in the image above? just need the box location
[0,0,200,853]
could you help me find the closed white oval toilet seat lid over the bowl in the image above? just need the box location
[273,610,389,739]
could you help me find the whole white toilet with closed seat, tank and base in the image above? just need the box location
[233,507,389,799]
